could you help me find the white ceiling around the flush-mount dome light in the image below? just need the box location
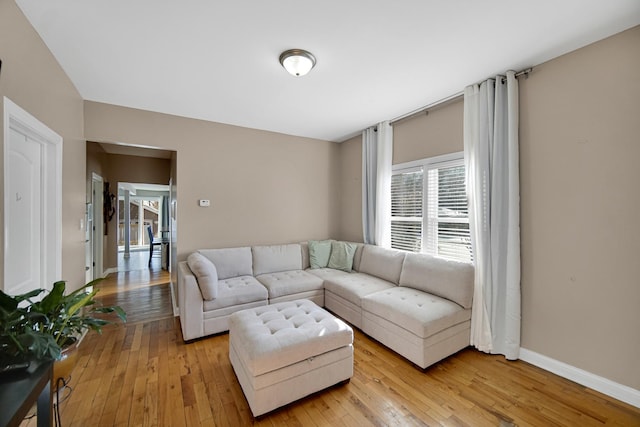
[16,0,640,141]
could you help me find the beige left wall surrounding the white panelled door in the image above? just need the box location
[0,0,86,289]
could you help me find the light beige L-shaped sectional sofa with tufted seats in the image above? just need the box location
[178,240,474,368]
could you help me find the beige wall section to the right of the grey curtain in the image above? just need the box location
[520,27,640,389]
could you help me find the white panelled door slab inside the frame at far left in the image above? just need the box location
[5,125,44,294]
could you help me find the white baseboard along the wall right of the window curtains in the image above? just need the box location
[520,348,640,408]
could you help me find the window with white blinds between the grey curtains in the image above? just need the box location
[391,153,473,261]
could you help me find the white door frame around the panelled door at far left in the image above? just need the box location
[2,96,63,289]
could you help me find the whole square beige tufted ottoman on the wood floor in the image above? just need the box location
[229,300,353,417]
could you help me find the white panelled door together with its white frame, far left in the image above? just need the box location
[0,97,62,294]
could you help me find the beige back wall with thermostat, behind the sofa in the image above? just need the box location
[85,102,339,259]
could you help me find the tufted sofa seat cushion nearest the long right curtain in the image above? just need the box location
[362,286,471,338]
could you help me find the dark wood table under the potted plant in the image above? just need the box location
[0,360,53,427]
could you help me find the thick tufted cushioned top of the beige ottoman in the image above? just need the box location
[229,300,353,376]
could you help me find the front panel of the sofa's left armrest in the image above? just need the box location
[178,261,204,341]
